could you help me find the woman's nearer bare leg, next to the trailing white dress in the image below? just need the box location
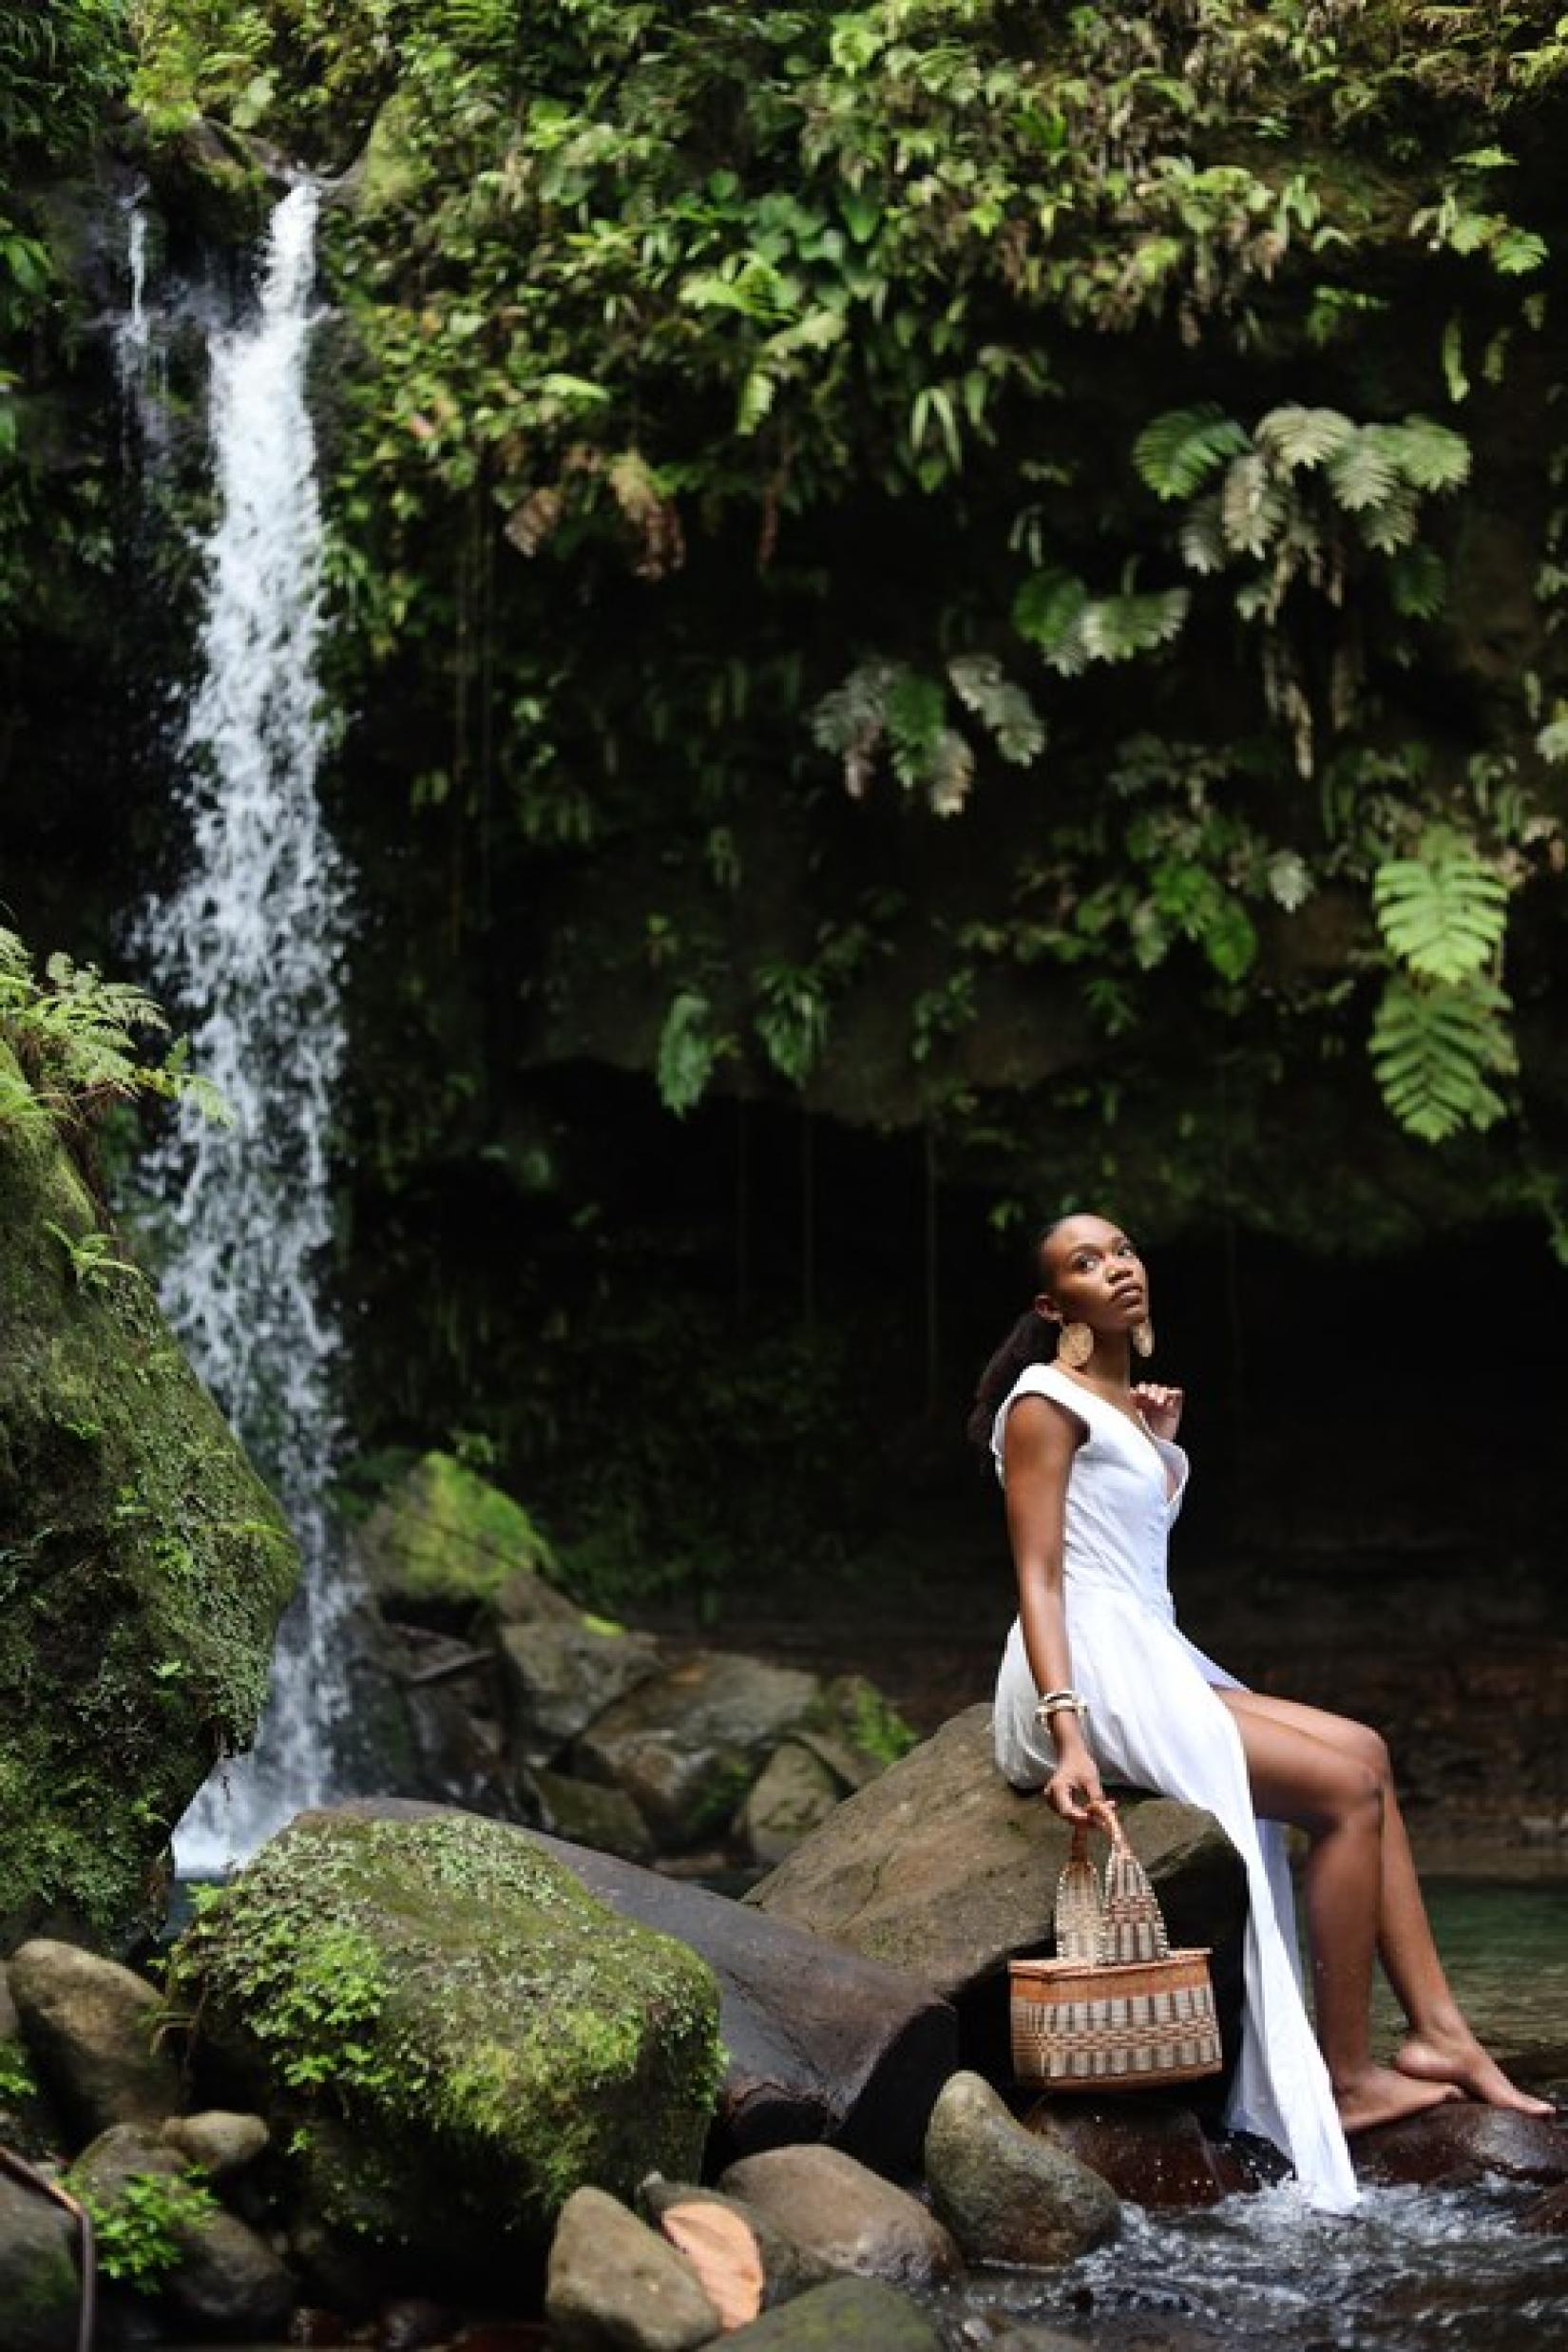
[1215,1692,1455,2131]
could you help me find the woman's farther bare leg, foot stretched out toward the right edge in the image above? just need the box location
[1217,1692,1554,2114]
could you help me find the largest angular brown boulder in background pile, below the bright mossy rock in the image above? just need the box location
[574,1649,823,1848]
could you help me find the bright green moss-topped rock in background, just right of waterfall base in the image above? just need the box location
[357,1454,555,1614]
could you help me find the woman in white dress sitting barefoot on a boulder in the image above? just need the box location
[968,1216,1552,2209]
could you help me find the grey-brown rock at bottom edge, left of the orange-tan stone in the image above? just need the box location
[545,2188,721,2352]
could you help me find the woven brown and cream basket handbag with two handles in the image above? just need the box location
[1008,1804,1222,2091]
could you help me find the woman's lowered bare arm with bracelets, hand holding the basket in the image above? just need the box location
[1004,1397,1105,1821]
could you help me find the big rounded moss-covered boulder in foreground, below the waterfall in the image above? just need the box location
[169,1807,721,2277]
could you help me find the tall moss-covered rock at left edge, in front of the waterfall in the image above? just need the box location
[0,1044,298,1945]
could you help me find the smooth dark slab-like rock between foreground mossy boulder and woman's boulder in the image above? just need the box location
[520,1832,957,2170]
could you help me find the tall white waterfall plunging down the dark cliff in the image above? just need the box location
[120,186,348,1872]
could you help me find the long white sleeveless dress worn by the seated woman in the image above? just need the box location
[992,1365,1356,2213]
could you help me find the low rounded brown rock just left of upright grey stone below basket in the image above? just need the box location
[719,2148,959,2286]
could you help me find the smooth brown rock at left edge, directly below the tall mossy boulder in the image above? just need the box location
[10,1936,181,2140]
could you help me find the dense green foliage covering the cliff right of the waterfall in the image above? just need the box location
[125,0,1568,1185]
